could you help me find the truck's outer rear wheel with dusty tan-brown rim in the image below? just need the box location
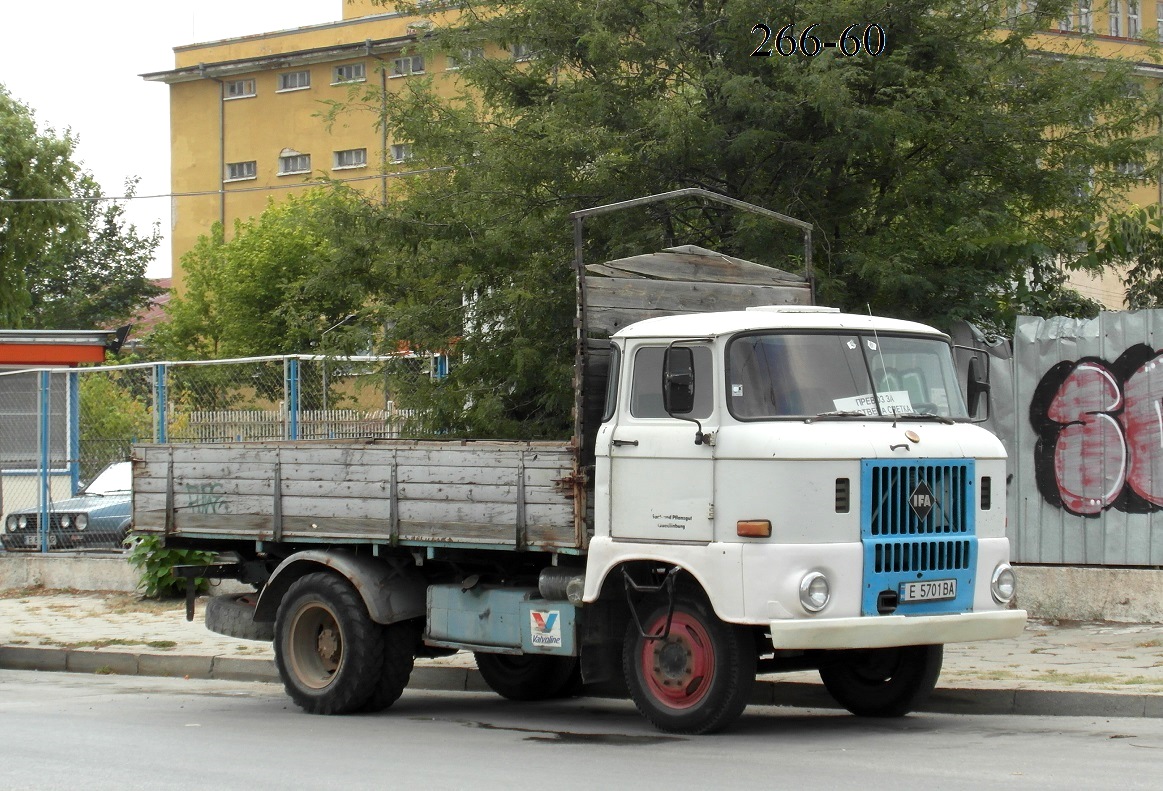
[274,572,385,714]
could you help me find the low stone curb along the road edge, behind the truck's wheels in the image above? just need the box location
[0,646,1163,719]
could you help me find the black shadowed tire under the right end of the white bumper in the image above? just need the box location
[820,646,944,717]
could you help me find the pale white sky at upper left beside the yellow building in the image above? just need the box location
[0,0,343,277]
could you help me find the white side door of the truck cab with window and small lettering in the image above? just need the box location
[609,343,715,542]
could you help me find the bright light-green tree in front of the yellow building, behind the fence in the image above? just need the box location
[152,185,379,359]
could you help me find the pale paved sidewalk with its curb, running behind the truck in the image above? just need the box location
[0,589,1163,718]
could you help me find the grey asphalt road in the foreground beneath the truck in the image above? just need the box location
[0,670,1163,791]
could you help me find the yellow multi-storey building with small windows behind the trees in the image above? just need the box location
[150,0,1163,307]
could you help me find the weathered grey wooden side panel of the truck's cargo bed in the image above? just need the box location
[134,440,585,548]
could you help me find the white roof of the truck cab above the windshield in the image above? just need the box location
[613,305,948,339]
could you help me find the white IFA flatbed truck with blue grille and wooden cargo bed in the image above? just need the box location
[133,191,1026,734]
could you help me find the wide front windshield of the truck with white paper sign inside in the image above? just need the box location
[727,333,969,420]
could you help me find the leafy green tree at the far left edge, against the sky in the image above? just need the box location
[0,86,160,329]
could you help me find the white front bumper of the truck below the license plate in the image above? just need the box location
[771,610,1026,650]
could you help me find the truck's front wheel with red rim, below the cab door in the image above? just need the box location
[622,594,757,734]
